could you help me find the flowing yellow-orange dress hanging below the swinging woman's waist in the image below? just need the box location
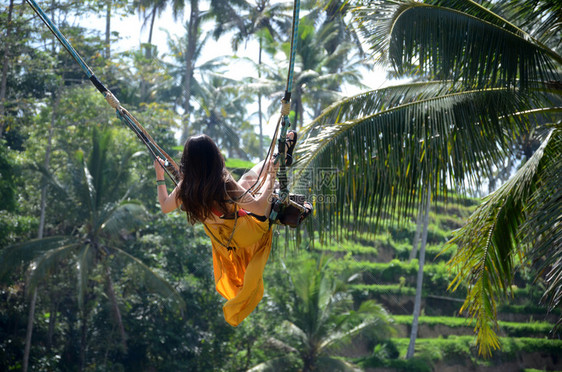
[205,211,273,327]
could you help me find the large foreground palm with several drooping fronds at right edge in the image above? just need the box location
[297,0,562,354]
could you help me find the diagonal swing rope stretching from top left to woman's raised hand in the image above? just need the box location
[27,0,180,185]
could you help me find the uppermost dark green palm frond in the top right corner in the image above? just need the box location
[357,0,562,87]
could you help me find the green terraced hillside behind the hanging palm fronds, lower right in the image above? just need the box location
[315,198,562,371]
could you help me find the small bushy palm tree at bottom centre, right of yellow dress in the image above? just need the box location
[250,257,393,371]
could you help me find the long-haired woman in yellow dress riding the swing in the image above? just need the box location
[154,131,297,326]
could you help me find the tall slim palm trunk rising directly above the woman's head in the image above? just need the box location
[182,0,200,140]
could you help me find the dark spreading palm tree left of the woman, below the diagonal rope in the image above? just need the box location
[0,128,181,367]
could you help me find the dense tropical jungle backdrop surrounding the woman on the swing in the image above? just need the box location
[0,0,562,371]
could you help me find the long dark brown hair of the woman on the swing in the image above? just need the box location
[177,134,232,224]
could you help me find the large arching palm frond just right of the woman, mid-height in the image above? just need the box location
[294,85,542,238]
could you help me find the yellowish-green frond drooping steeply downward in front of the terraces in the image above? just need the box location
[447,129,549,355]
